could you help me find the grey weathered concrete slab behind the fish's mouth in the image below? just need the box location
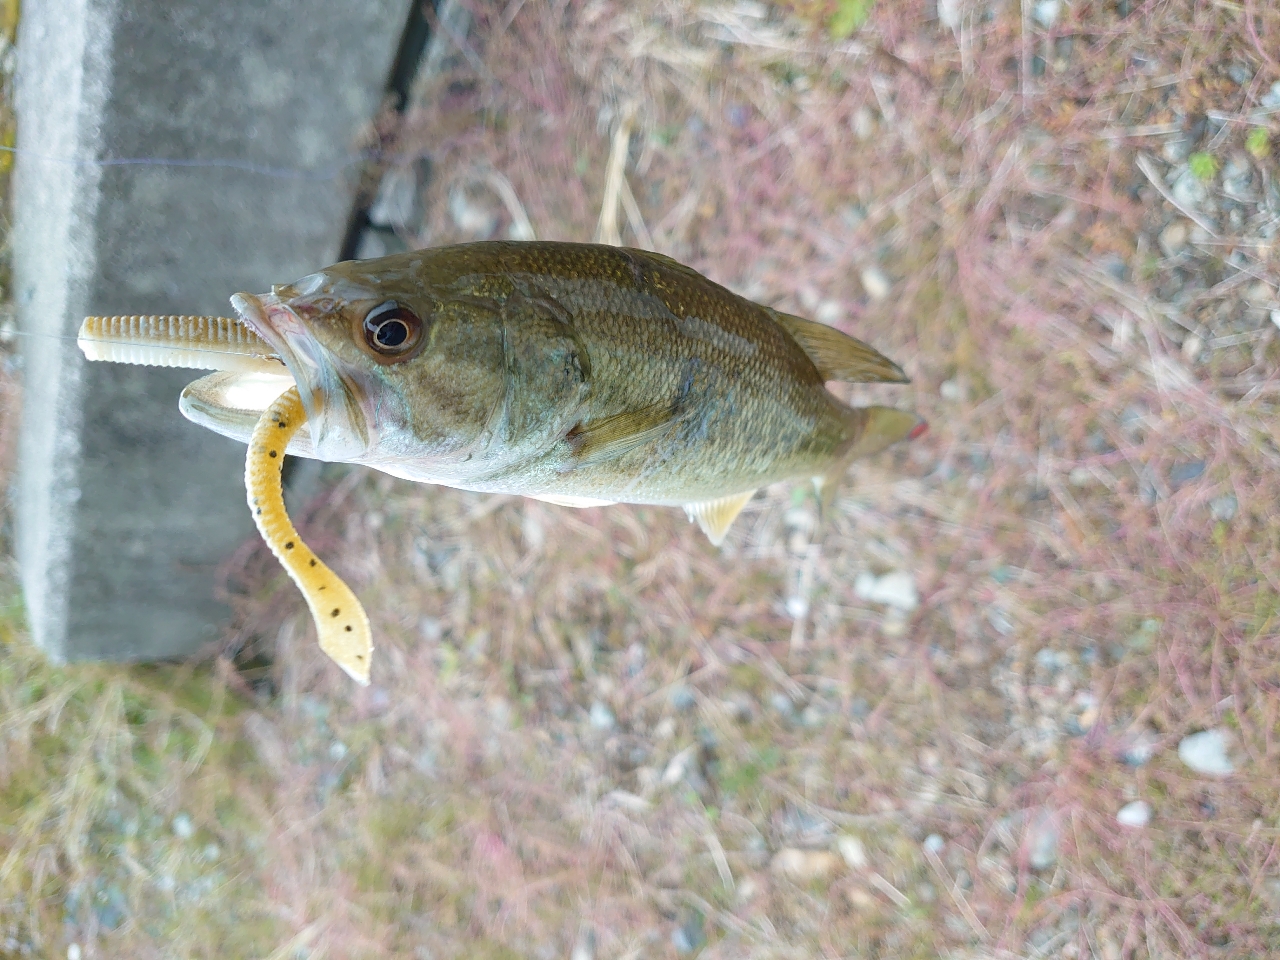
[14,0,408,659]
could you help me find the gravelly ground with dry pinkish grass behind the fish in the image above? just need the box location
[0,0,1280,960]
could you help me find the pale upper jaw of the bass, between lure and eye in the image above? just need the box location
[232,293,372,461]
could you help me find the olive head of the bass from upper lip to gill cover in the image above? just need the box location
[232,257,504,462]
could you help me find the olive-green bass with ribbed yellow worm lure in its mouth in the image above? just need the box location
[81,242,924,680]
